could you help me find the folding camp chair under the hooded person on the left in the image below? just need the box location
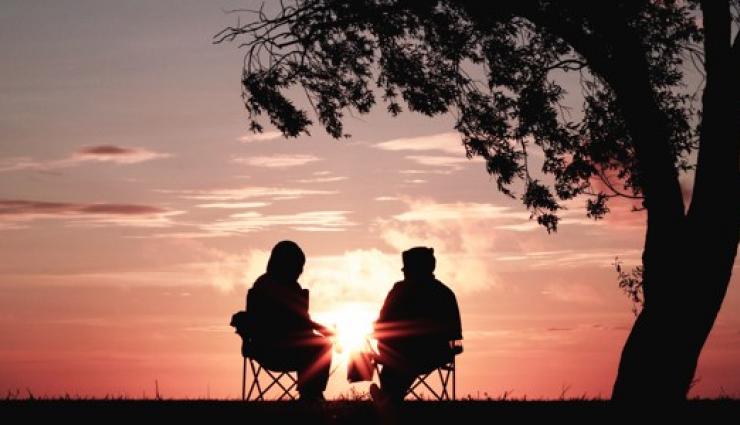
[231,289,308,401]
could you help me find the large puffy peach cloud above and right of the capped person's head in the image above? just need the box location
[376,199,640,288]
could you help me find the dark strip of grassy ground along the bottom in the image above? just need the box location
[0,399,740,425]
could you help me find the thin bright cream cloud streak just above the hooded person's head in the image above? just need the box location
[201,211,355,235]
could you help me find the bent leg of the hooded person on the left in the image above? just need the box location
[295,335,332,398]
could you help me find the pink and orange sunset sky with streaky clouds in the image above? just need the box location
[0,0,740,399]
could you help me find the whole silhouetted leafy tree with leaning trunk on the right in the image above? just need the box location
[215,0,740,400]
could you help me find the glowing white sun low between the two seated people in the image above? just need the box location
[322,303,377,356]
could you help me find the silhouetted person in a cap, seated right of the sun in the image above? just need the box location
[371,247,462,401]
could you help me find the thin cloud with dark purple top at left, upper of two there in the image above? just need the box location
[0,145,172,172]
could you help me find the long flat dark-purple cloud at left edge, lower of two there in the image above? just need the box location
[0,200,183,228]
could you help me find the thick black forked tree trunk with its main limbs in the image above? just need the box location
[466,0,740,402]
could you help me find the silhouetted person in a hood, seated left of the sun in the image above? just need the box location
[247,241,332,400]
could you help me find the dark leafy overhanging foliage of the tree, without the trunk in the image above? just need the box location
[216,0,702,231]
